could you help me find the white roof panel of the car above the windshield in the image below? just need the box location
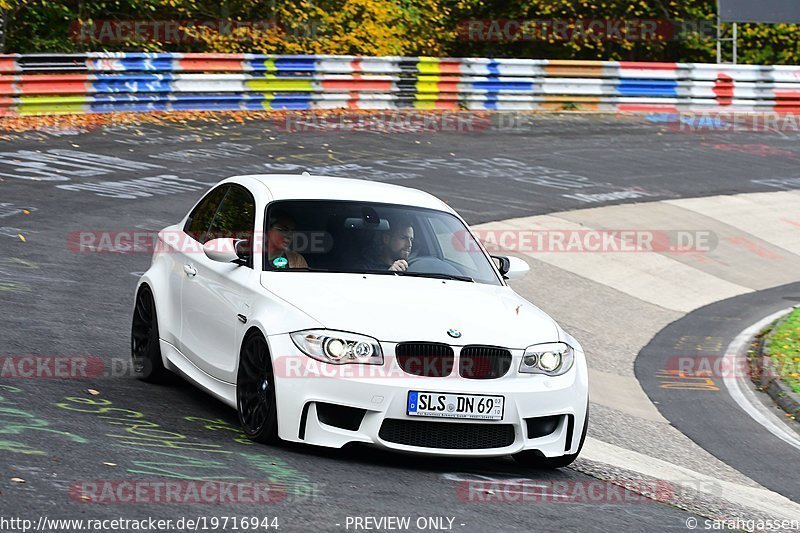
[223,174,453,212]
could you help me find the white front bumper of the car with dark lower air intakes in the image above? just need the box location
[268,335,588,457]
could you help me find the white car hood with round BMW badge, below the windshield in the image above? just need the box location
[261,272,560,349]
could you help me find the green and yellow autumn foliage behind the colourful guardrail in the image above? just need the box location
[0,0,800,64]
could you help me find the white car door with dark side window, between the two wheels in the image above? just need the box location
[181,184,258,383]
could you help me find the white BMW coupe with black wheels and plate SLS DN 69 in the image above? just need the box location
[131,174,589,468]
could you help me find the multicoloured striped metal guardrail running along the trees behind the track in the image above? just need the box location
[0,52,800,115]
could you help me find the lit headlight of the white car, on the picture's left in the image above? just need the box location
[291,329,383,365]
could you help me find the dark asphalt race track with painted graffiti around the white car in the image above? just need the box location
[0,111,800,532]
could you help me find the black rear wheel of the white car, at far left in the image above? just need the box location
[131,285,169,383]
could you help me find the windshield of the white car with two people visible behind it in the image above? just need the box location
[264,200,501,285]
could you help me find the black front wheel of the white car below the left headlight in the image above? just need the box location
[236,333,280,444]
